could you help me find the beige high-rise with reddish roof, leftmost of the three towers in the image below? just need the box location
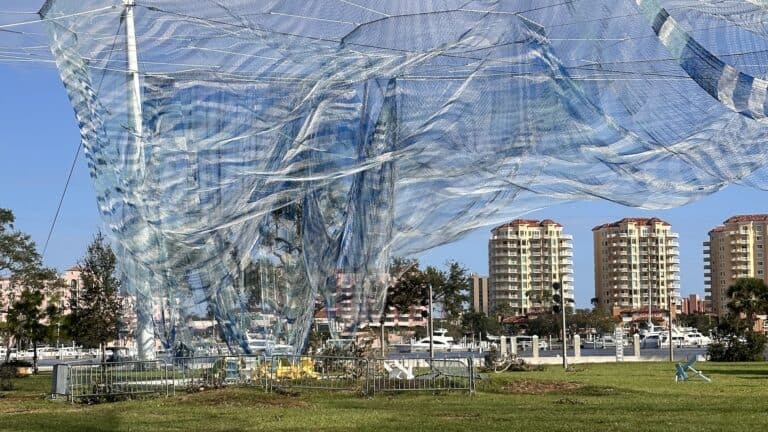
[488,219,573,315]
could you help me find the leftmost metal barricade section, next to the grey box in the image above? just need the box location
[68,360,173,401]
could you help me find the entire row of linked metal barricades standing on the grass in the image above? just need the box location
[60,353,478,402]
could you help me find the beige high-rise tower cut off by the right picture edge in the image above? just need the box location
[704,214,768,316]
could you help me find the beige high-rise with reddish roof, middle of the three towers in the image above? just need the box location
[592,218,680,315]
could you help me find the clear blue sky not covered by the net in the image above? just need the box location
[0,1,766,307]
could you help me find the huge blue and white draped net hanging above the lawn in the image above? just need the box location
[41,0,768,351]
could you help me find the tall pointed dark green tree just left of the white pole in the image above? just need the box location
[69,232,121,360]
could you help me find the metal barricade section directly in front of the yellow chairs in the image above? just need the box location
[265,355,369,393]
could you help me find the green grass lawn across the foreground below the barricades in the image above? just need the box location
[0,363,768,432]
